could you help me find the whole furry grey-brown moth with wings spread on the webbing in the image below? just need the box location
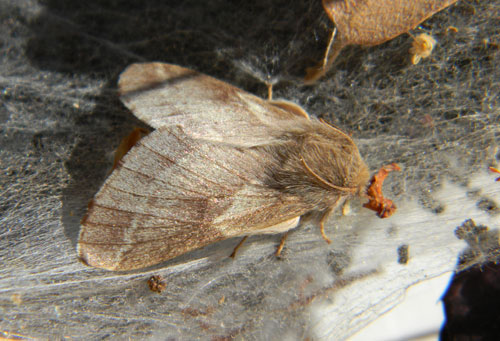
[78,63,369,270]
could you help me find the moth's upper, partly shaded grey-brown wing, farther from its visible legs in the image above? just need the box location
[118,63,308,146]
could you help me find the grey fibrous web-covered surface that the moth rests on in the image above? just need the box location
[0,0,500,339]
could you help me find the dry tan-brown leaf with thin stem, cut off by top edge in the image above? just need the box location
[305,0,457,83]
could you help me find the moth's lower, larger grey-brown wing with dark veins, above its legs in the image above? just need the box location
[78,127,302,270]
